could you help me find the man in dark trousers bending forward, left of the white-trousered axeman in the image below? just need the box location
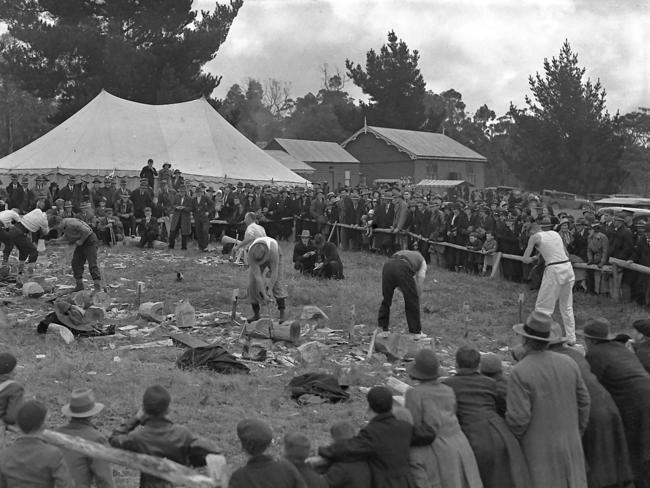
[377,250,427,338]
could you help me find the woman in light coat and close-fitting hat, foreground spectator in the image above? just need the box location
[405,349,483,488]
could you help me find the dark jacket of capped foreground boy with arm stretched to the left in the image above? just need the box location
[318,412,420,488]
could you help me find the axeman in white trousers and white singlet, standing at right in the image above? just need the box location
[523,223,576,345]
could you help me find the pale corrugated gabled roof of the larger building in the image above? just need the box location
[341,126,487,162]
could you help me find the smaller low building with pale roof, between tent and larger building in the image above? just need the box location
[264,138,359,188]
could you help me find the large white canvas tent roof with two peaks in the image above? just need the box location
[0,91,306,185]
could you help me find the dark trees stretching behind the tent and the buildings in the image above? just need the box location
[0,0,650,194]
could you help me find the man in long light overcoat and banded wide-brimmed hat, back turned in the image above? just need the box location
[506,310,590,488]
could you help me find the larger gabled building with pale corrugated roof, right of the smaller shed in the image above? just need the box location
[341,126,487,188]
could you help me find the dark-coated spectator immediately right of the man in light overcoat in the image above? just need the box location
[548,323,634,488]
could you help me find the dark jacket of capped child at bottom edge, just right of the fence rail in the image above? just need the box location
[228,454,308,488]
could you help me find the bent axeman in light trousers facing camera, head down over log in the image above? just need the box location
[248,237,287,323]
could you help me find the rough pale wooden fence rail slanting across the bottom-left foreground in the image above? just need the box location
[41,430,226,488]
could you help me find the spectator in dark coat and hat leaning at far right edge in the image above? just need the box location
[580,317,650,487]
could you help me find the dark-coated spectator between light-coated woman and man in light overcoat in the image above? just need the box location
[444,346,531,488]
